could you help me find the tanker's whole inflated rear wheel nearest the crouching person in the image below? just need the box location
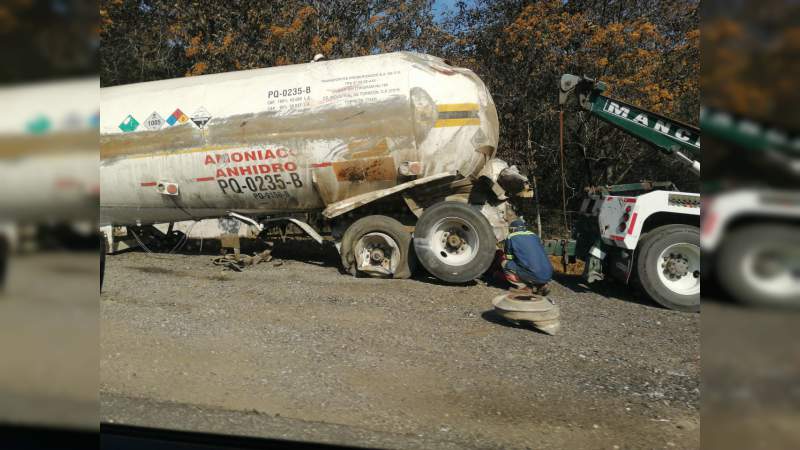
[414,202,497,283]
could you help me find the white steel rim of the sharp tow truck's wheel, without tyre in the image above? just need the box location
[657,242,700,295]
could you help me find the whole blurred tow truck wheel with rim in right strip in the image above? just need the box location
[716,224,800,308]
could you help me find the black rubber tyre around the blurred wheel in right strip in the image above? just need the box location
[715,224,800,308]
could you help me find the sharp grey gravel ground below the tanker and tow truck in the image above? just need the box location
[100,244,700,449]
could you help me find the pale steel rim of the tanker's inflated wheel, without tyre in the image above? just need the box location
[430,217,480,266]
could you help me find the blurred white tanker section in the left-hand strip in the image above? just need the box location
[0,78,100,284]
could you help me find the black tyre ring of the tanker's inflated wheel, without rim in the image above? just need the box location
[414,201,497,283]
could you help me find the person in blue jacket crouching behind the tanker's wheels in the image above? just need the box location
[500,219,553,295]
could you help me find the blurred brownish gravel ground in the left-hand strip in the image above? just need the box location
[0,252,99,430]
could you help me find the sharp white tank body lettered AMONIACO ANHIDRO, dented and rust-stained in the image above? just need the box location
[100,52,499,225]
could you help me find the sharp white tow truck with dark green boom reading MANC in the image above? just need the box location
[556,74,701,312]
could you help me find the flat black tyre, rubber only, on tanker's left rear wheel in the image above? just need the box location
[340,215,416,278]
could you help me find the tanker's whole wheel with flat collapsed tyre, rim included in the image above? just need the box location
[341,215,415,278]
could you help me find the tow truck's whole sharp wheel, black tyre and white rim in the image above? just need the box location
[636,224,701,312]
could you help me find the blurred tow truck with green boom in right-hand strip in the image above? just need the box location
[700,108,800,308]
